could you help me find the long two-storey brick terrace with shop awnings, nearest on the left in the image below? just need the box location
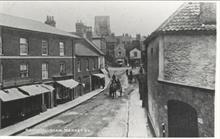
[0,14,106,128]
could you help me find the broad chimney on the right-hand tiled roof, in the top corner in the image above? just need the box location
[199,2,216,24]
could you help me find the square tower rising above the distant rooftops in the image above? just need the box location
[95,16,111,36]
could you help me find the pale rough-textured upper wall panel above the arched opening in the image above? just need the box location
[162,35,216,89]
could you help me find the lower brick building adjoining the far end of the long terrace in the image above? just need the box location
[75,38,105,95]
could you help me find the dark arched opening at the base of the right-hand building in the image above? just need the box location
[168,100,198,137]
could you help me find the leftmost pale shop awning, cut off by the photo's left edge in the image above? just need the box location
[0,88,28,102]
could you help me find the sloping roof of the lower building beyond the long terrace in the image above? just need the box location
[75,42,98,56]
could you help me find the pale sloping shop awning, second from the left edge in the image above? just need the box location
[19,84,50,96]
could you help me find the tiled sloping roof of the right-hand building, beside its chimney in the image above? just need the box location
[145,2,216,41]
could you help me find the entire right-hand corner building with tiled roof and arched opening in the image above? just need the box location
[142,2,216,137]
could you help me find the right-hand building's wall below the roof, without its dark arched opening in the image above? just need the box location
[147,34,215,137]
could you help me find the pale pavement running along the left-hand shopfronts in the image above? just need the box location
[0,76,110,136]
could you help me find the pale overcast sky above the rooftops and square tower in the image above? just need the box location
[0,1,183,35]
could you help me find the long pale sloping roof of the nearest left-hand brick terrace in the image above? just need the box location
[0,13,80,38]
